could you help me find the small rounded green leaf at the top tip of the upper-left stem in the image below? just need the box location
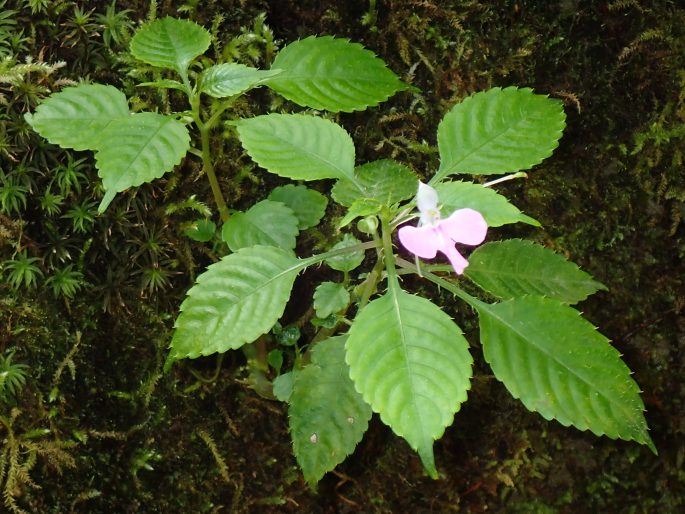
[130,16,211,76]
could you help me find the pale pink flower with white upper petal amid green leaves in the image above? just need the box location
[398,182,488,275]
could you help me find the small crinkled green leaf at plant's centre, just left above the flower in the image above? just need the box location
[331,159,418,207]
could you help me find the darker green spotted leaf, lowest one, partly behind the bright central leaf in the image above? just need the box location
[288,337,372,487]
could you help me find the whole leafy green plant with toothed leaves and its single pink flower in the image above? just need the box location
[27,18,656,485]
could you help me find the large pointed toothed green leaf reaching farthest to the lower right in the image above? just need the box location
[477,296,656,451]
